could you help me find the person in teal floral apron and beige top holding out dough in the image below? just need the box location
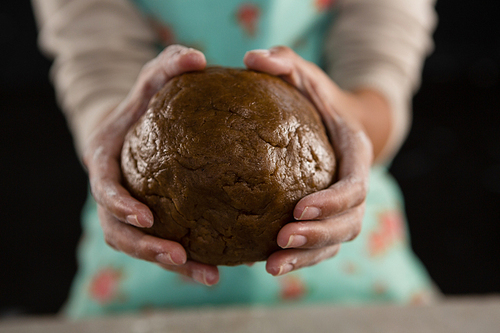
[33,0,435,317]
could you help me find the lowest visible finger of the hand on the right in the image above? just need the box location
[266,244,340,276]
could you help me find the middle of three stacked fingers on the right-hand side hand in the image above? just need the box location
[277,204,365,249]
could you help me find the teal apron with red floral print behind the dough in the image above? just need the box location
[64,0,434,317]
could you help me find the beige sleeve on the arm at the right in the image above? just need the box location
[326,0,437,161]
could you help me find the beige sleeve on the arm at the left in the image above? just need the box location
[32,0,156,156]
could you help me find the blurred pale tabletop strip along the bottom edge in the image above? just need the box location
[0,296,500,333]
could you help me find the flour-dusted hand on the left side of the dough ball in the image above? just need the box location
[83,45,219,285]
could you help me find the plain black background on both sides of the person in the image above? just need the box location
[0,0,500,318]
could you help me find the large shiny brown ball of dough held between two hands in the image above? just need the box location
[122,67,335,265]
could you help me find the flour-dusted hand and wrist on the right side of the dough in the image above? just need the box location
[244,47,390,275]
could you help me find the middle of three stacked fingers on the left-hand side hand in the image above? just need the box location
[98,206,187,265]
